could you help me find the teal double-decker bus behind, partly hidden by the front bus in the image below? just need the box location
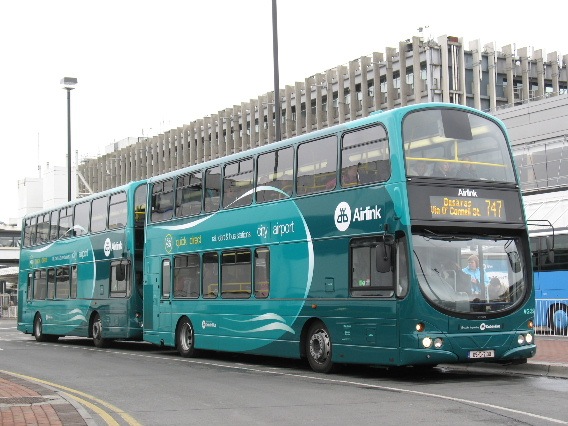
[18,181,147,347]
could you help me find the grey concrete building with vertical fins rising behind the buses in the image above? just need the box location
[71,36,568,196]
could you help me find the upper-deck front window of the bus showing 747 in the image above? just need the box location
[403,109,515,182]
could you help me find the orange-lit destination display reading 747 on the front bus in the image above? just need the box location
[430,195,507,221]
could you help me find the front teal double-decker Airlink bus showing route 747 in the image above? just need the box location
[144,103,536,372]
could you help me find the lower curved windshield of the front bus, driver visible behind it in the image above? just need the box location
[412,232,528,314]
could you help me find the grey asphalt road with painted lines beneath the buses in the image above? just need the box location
[0,323,568,426]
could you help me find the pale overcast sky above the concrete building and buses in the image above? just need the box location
[0,0,568,221]
